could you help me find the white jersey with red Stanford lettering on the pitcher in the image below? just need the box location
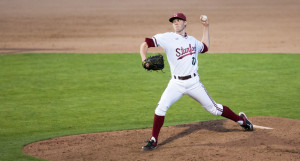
[152,32,204,76]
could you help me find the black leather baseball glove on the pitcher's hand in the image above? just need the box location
[142,54,165,70]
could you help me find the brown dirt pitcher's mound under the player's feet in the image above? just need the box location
[23,117,300,161]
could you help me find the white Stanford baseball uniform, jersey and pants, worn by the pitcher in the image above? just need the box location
[147,32,223,116]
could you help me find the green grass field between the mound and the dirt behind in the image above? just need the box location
[0,54,300,161]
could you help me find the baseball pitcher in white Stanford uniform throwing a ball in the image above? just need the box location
[140,13,253,150]
